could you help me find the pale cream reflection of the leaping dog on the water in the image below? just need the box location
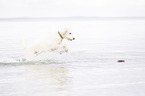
[25,64,70,96]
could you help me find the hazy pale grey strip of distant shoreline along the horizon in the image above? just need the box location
[0,16,145,21]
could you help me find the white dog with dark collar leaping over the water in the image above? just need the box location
[22,29,75,60]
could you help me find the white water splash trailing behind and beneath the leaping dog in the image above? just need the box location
[0,53,65,65]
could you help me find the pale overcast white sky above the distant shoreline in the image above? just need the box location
[0,0,145,18]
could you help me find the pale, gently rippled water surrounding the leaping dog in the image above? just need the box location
[0,20,145,96]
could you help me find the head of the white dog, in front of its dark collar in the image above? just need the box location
[61,29,75,41]
